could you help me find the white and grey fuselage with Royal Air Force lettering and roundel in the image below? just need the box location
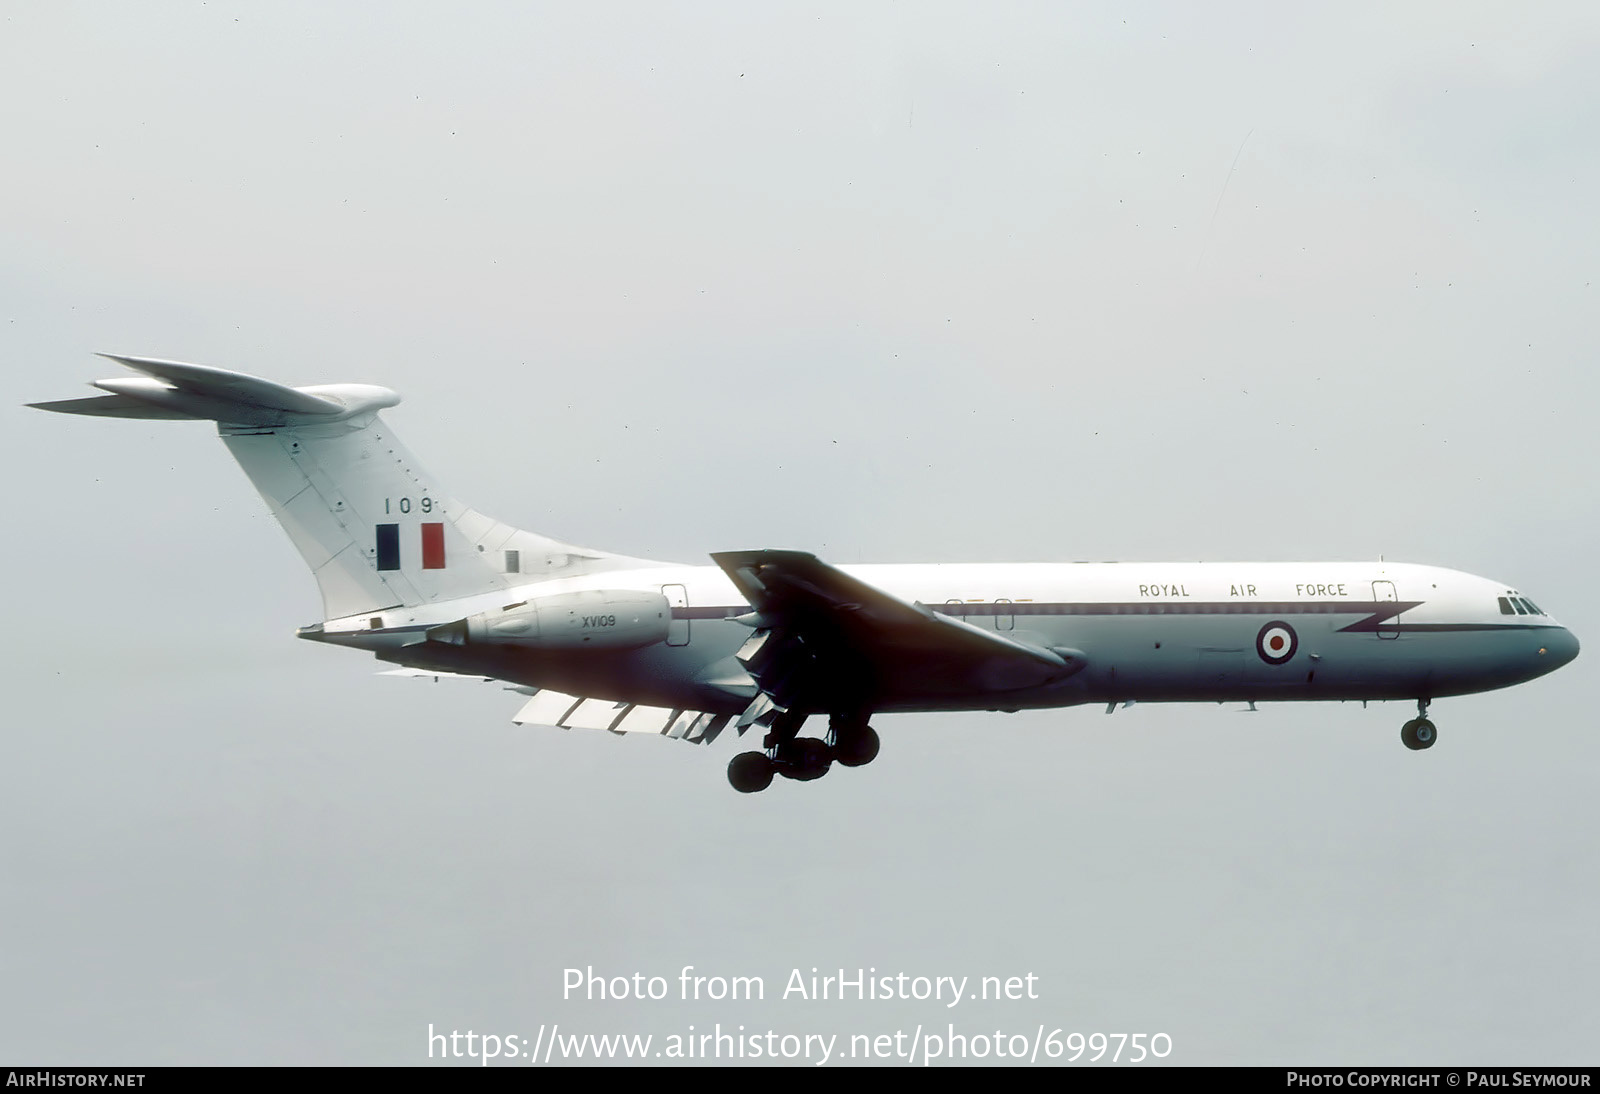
[307,561,1578,713]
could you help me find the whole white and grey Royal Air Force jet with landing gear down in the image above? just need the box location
[34,357,1578,792]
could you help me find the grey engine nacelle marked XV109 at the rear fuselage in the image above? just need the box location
[427,589,672,649]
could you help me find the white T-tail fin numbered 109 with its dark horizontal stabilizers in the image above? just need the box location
[30,355,648,619]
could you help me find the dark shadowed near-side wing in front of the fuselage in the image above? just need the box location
[712,550,1085,721]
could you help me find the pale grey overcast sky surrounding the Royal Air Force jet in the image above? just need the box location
[0,3,1600,1064]
